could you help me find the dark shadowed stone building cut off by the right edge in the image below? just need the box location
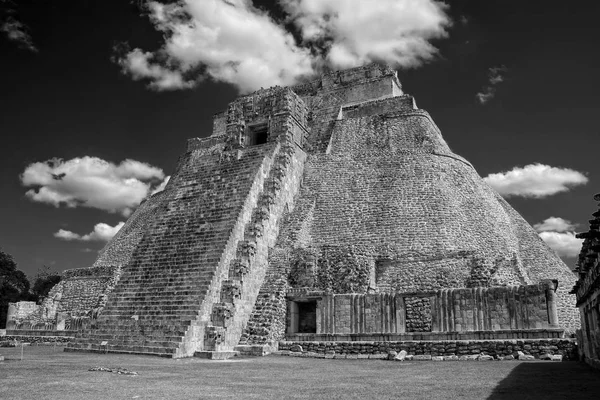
[572,194,600,368]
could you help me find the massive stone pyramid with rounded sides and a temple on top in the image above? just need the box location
[2,65,579,357]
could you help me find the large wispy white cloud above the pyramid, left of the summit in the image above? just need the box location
[120,0,313,92]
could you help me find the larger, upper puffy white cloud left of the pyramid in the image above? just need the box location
[20,156,165,216]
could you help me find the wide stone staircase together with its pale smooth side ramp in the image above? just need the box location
[66,143,285,357]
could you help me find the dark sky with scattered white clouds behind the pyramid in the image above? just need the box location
[0,0,600,274]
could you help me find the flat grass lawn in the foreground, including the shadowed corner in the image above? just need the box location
[0,346,600,400]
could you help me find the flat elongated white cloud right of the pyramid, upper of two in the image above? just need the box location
[484,164,588,198]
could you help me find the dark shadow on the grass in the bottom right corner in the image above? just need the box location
[488,361,600,400]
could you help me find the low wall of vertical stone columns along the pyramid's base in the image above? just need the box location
[287,282,562,340]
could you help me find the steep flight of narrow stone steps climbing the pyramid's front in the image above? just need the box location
[73,140,279,356]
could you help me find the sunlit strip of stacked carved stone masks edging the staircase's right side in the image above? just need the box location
[195,143,306,359]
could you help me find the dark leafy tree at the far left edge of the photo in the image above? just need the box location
[0,249,30,329]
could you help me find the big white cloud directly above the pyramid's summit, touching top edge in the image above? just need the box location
[280,0,450,68]
